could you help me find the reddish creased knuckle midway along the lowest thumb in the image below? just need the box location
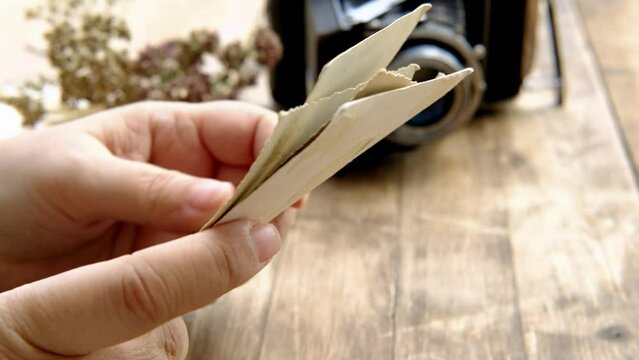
[119,256,170,323]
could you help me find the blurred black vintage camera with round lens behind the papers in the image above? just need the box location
[268,0,538,147]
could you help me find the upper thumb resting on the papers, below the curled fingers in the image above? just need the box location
[74,157,234,232]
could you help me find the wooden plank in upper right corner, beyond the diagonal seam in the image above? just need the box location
[578,0,639,171]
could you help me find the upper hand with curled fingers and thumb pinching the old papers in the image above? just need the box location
[0,102,291,291]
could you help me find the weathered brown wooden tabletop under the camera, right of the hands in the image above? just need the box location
[0,0,639,360]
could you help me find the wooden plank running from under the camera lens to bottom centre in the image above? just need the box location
[260,162,401,360]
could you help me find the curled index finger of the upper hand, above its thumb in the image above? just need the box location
[86,101,277,176]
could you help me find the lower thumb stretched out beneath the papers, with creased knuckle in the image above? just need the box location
[0,221,280,356]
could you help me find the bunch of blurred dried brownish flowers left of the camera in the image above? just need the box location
[0,0,282,124]
